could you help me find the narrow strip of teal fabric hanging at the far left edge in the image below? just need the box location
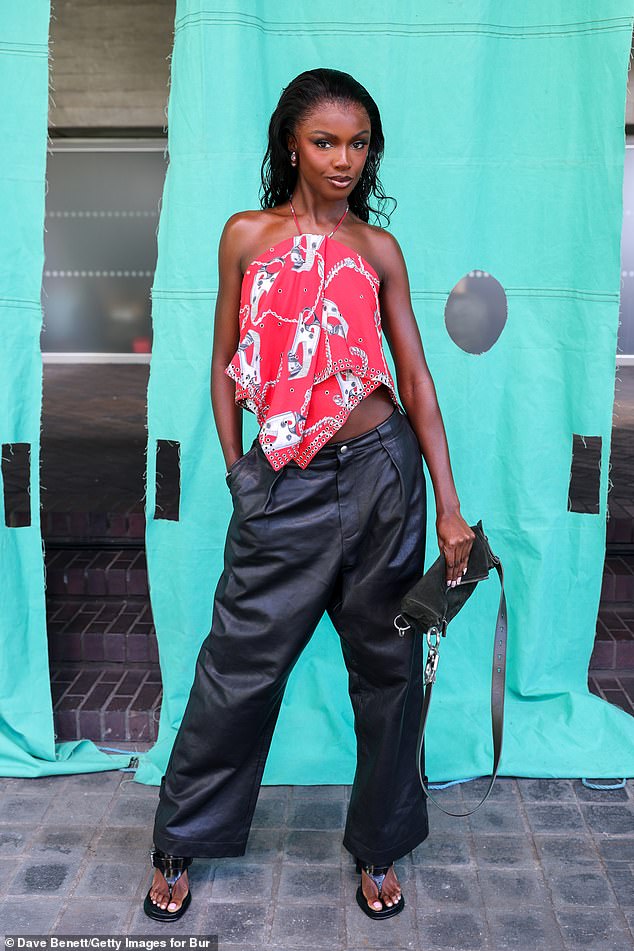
[0,0,130,776]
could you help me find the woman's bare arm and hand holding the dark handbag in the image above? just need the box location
[376,231,475,585]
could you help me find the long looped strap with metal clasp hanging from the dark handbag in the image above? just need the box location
[416,554,508,816]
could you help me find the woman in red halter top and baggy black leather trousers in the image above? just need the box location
[144,69,474,920]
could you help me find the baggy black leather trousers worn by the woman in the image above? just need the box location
[153,407,429,865]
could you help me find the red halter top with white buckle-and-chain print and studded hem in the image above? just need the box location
[224,209,400,469]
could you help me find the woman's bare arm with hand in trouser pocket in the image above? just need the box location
[211,213,243,469]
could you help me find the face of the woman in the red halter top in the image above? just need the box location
[289,102,371,200]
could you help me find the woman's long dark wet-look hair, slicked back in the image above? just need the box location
[260,69,397,224]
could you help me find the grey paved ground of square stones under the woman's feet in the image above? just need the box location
[0,771,634,951]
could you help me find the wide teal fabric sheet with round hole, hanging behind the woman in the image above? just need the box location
[136,0,634,783]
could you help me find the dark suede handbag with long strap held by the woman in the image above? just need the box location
[394,519,507,816]
